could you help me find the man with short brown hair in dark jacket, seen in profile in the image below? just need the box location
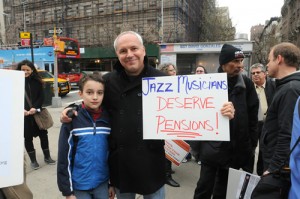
[251,42,300,199]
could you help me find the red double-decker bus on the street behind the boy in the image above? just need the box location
[57,37,81,86]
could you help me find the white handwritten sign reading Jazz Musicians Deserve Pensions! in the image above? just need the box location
[142,73,229,141]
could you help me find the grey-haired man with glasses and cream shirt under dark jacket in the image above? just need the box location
[247,63,275,176]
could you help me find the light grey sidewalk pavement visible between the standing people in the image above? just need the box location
[26,107,200,199]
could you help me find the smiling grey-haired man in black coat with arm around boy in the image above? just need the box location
[104,31,165,199]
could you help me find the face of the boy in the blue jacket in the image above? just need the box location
[79,80,104,111]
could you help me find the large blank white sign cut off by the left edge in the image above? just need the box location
[0,69,25,188]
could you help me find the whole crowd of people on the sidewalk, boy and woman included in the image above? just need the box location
[1,31,300,199]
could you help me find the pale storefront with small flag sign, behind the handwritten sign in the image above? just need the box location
[160,41,253,75]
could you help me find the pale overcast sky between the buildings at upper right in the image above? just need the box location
[217,0,284,37]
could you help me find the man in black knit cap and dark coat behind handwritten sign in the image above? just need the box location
[194,44,259,199]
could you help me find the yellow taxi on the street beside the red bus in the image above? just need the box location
[38,70,71,96]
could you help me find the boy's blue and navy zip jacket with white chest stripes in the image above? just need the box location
[57,106,110,196]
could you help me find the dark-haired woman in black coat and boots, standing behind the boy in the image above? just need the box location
[17,60,55,169]
